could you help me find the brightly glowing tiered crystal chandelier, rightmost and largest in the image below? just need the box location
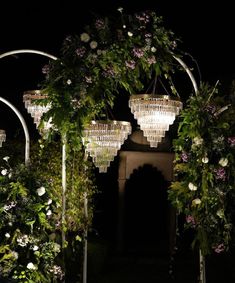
[129,94,183,147]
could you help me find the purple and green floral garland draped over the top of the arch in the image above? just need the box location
[40,9,180,141]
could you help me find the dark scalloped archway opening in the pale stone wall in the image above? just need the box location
[124,164,169,255]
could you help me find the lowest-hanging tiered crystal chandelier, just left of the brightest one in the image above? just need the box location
[83,120,131,173]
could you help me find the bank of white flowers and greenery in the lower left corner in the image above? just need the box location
[0,157,63,283]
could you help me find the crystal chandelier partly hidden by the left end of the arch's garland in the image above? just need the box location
[23,90,52,133]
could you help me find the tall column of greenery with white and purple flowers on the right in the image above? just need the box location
[169,84,235,255]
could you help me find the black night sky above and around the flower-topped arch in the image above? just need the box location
[0,0,235,138]
